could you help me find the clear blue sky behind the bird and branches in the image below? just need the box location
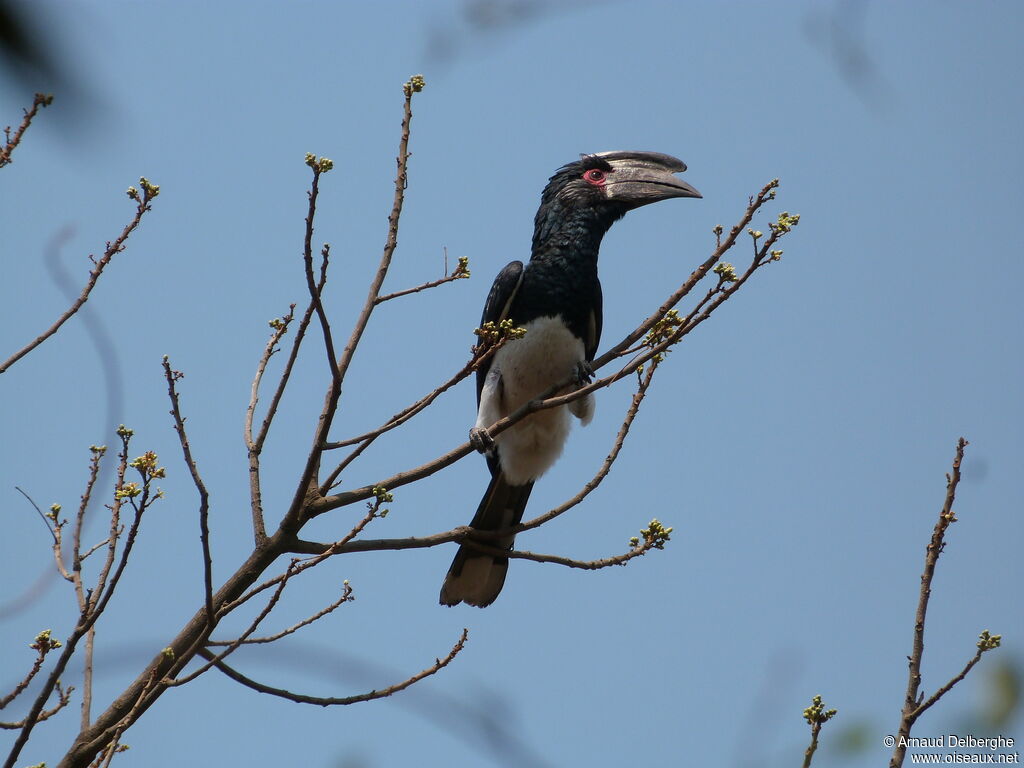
[0,0,1024,768]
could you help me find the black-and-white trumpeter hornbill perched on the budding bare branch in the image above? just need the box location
[440,152,700,608]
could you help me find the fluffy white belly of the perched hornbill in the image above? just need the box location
[476,317,594,484]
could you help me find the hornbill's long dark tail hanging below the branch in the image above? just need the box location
[440,470,534,608]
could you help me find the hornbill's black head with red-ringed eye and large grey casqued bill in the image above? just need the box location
[534,152,701,253]
